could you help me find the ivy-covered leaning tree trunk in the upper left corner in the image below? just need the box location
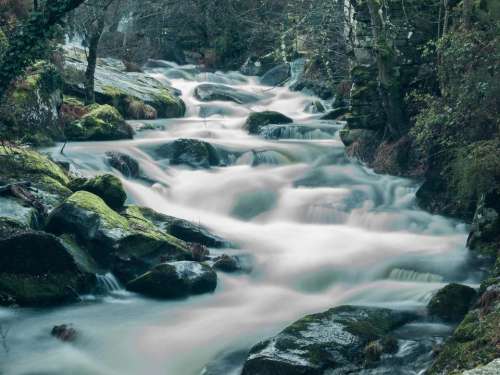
[0,0,85,101]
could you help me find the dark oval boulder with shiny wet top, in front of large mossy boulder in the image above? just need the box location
[127,261,217,299]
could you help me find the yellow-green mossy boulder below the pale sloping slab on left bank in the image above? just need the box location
[65,105,134,141]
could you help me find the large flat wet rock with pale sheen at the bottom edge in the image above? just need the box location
[242,306,414,375]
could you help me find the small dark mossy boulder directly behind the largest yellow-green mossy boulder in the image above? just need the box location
[69,174,127,209]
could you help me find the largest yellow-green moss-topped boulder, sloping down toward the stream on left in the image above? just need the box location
[47,191,189,270]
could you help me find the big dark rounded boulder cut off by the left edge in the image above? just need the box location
[0,231,96,306]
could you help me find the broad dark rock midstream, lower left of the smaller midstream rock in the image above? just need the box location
[156,138,221,168]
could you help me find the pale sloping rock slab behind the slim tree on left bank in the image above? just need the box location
[64,50,186,119]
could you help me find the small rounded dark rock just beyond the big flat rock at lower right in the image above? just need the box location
[427,284,477,322]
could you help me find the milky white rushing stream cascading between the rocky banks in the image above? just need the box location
[0,60,471,375]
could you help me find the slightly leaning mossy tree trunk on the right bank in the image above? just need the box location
[367,0,408,139]
